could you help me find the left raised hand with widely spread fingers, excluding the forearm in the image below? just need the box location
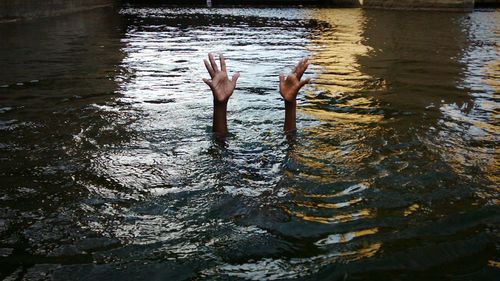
[203,53,240,104]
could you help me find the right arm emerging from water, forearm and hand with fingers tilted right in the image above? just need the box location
[280,58,311,133]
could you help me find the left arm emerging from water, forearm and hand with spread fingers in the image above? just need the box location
[203,53,240,134]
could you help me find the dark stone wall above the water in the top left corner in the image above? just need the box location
[0,0,115,21]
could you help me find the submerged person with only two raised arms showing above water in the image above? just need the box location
[203,53,310,135]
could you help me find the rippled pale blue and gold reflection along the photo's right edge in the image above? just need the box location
[427,12,500,188]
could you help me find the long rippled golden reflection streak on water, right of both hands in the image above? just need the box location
[282,12,384,262]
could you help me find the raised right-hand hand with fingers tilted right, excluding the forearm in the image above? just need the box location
[279,57,311,102]
